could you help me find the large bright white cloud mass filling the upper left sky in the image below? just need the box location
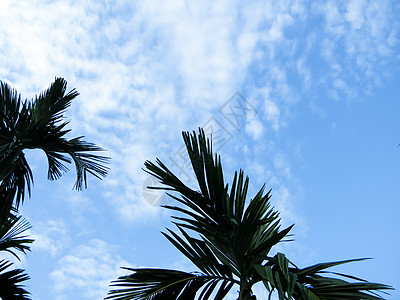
[0,1,266,221]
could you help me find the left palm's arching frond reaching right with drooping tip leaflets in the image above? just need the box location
[27,78,109,190]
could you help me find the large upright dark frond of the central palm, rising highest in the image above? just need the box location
[145,128,291,276]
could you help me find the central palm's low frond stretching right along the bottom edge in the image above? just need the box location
[255,253,392,300]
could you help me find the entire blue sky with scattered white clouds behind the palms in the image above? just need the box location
[0,0,400,300]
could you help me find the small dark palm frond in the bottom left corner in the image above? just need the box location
[0,259,31,300]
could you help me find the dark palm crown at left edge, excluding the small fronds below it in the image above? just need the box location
[0,78,108,223]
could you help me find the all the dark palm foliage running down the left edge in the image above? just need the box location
[0,78,108,300]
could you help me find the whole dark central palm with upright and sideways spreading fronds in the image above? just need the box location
[106,129,390,300]
